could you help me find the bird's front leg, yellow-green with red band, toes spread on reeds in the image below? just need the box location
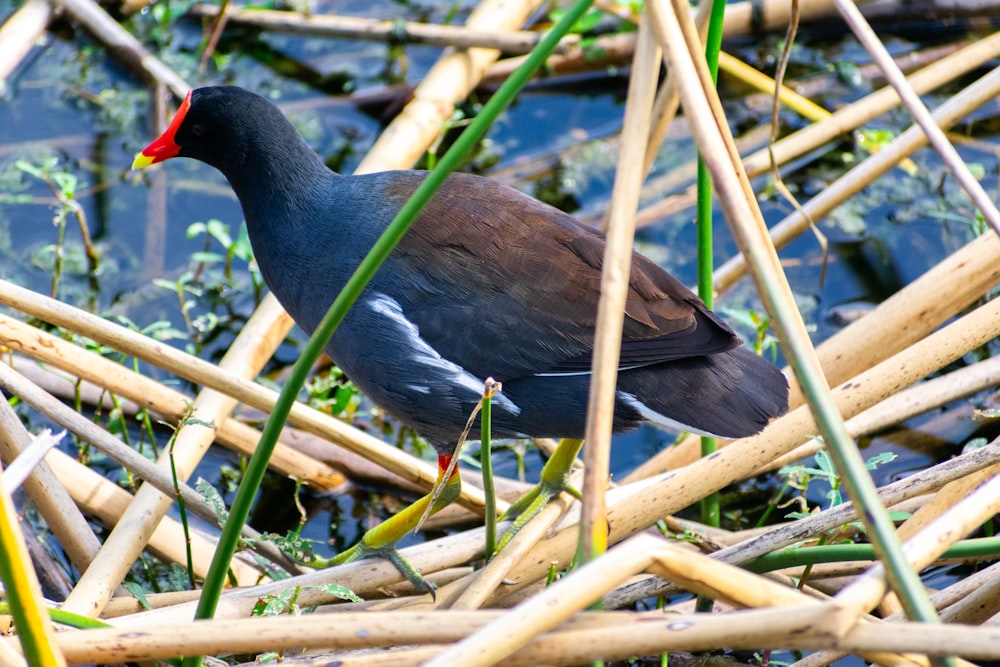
[310,456,462,594]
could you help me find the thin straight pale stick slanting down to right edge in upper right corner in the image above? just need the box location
[834,0,1000,234]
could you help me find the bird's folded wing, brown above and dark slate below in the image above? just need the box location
[378,174,740,380]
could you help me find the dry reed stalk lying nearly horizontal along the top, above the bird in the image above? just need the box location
[188,4,580,54]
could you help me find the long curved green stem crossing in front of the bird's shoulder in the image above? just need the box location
[183,0,592,667]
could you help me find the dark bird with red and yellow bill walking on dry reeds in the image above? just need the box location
[132,86,788,587]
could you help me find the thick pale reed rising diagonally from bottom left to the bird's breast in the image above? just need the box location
[63,294,292,616]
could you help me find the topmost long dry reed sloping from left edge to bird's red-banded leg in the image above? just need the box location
[0,280,492,513]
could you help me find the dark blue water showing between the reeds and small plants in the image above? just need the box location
[0,2,998,664]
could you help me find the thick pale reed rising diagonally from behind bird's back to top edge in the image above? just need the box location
[357,0,539,173]
